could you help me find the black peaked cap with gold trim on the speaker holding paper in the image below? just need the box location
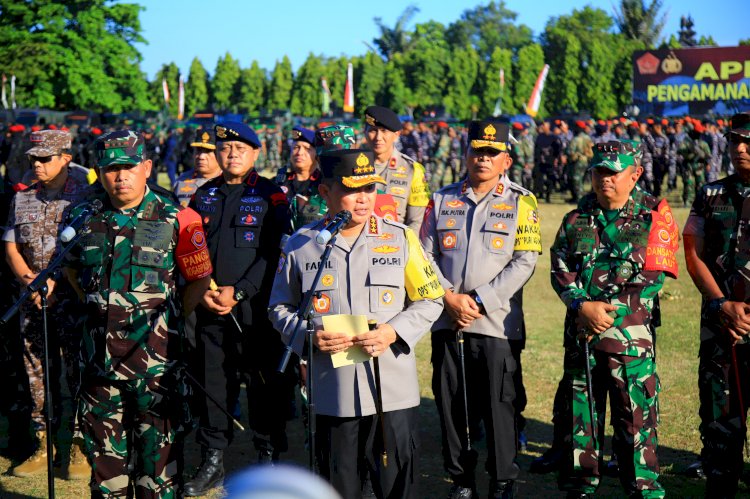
[320,149,386,189]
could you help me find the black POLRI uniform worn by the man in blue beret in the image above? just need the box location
[190,170,294,456]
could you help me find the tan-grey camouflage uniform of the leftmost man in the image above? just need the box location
[3,149,90,438]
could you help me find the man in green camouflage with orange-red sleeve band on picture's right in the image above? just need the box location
[551,141,679,497]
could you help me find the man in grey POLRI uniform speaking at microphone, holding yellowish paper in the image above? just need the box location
[269,149,443,498]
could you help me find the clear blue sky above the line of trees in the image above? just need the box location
[134,0,750,78]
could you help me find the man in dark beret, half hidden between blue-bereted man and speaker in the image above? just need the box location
[275,126,327,230]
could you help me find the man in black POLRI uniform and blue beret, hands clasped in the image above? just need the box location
[185,122,295,496]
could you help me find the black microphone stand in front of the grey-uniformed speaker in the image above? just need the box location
[278,234,336,472]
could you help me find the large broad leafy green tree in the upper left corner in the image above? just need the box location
[0,0,152,112]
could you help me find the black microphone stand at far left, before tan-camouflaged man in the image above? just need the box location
[0,226,88,499]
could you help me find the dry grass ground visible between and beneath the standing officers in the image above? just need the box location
[0,186,750,499]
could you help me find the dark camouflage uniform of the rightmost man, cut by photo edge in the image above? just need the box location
[684,175,750,497]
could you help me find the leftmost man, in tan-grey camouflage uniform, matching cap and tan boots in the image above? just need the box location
[3,130,90,478]
